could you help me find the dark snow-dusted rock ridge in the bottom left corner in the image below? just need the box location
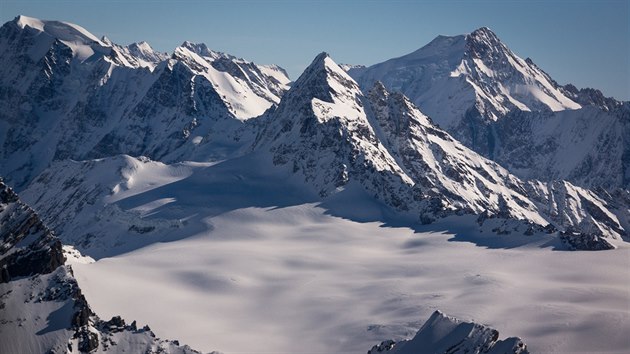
[0,180,198,353]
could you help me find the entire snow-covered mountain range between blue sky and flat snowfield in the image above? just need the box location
[0,16,630,353]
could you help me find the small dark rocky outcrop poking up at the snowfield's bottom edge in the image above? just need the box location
[368,311,529,354]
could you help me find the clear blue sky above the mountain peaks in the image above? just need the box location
[0,0,630,100]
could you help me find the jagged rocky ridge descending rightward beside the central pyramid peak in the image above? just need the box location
[368,82,629,248]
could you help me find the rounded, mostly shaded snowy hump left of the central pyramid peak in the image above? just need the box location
[18,155,212,258]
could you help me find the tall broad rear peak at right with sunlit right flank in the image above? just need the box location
[349,27,581,129]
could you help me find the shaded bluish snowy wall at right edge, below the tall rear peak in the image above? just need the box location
[492,104,630,190]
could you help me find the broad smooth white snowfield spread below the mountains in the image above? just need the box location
[74,200,630,353]
